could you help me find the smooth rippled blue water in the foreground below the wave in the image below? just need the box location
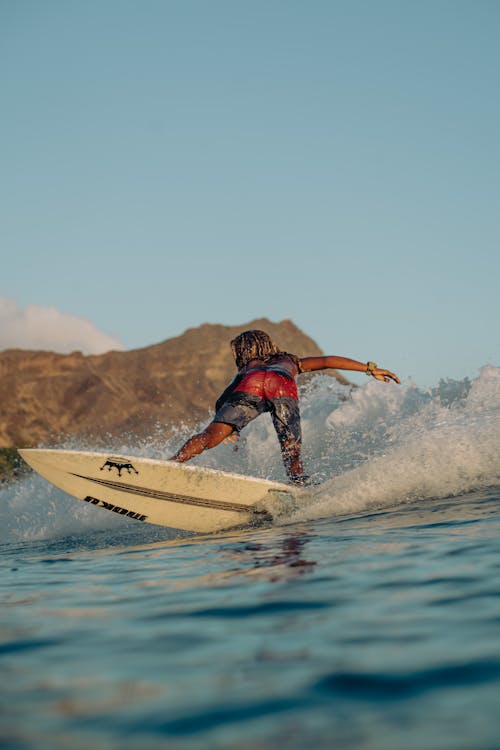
[0,491,500,750]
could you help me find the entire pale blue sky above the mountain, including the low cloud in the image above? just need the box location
[0,0,500,386]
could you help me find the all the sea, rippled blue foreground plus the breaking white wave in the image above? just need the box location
[0,366,500,750]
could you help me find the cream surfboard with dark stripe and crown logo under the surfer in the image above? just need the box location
[19,448,300,533]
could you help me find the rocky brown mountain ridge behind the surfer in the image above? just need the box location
[0,319,347,447]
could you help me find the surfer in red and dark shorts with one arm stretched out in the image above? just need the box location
[171,330,400,485]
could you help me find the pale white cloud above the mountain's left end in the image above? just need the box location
[0,297,124,354]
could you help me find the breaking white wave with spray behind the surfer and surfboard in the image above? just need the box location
[0,365,500,542]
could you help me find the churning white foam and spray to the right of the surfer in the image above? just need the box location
[295,366,500,519]
